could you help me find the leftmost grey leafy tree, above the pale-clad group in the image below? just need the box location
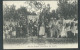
[3,5,19,21]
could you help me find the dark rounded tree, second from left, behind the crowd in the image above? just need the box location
[17,7,30,24]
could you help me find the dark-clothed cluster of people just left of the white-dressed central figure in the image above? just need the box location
[28,20,38,36]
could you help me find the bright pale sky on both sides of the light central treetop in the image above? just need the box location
[3,1,58,11]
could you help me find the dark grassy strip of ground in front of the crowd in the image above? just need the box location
[3,38,78,44]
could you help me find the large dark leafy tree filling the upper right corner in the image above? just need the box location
[57,0,78,19]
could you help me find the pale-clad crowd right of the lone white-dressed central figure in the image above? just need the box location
[50,19,78,37]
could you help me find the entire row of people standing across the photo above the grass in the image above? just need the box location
[3,18,78,38]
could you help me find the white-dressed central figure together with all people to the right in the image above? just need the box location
[39,18,78,38]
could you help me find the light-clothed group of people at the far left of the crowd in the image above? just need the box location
[3,24,16,38]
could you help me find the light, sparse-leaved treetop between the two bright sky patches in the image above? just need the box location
[26,1,44,13]
